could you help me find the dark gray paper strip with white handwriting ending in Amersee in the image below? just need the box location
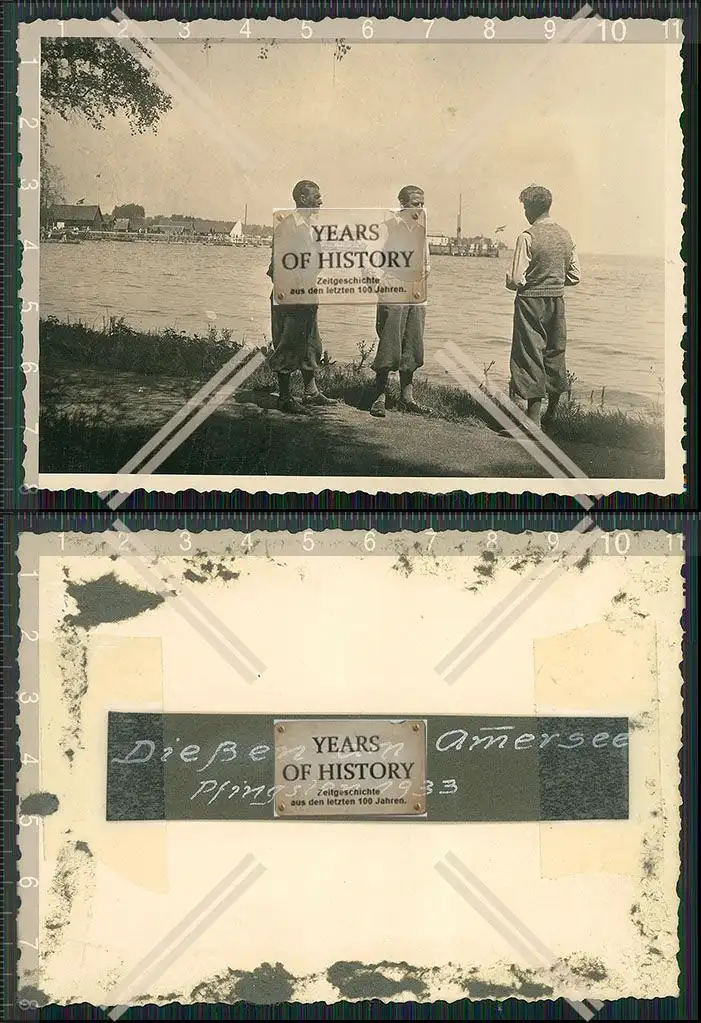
[106,712,628,821]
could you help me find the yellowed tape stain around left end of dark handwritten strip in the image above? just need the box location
[41,631,168,892]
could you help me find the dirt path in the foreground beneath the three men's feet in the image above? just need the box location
[43,373,663,476]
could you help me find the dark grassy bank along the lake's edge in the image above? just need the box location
[40,318,663,475]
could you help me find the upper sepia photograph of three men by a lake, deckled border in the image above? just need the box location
[21,18,684,494]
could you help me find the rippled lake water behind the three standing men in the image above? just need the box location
[40,241,664,407]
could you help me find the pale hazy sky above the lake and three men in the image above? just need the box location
[43,41,666,256]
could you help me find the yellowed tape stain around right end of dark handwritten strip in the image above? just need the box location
[533,618,659,878]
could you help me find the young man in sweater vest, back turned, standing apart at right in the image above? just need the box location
[507,185,580,427]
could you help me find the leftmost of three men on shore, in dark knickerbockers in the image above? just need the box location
[268,180,338,415]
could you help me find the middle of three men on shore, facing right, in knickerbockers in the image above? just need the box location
[370,185,431,418]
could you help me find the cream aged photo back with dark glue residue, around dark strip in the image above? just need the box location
[19,531,684,1006]
